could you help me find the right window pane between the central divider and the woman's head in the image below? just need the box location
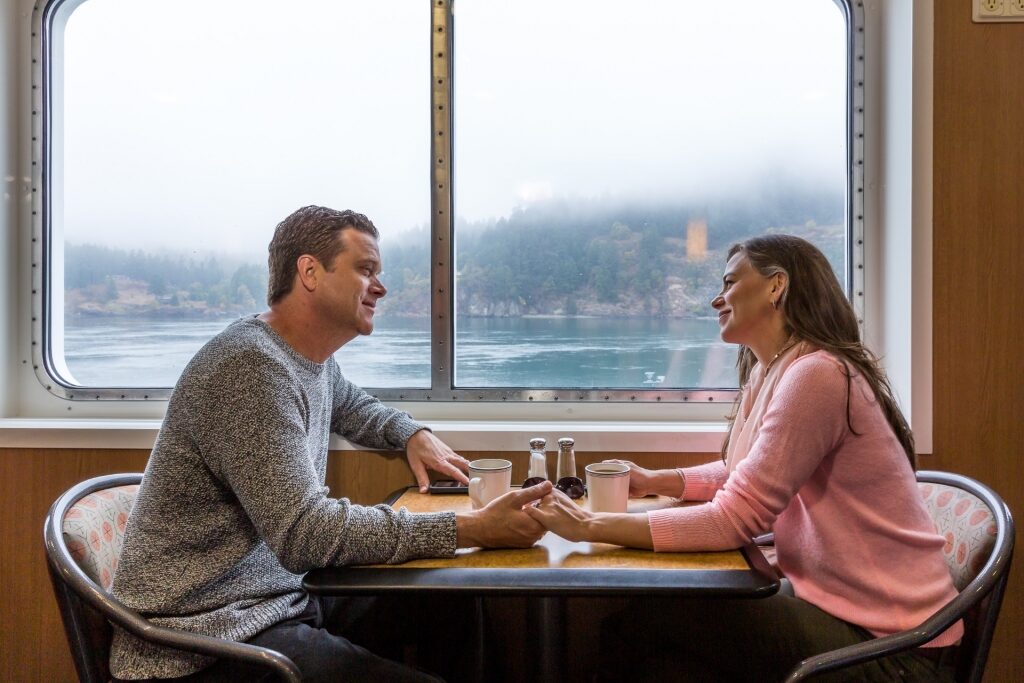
[454,0,848,397]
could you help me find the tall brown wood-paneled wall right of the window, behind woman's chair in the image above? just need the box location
[933,5,1024,683]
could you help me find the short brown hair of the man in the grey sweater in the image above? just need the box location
[266,206,380,305]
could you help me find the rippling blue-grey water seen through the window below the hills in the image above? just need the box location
[65,316,736,388]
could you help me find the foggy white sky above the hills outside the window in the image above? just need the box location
[63,0,846,258]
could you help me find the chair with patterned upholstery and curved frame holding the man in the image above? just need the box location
[43,474,302,683]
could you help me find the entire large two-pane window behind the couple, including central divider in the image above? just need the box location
[37,0,862,401]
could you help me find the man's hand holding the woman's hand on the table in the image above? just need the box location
[455,481,552,548]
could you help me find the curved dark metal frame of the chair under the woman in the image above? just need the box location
[785,471,1014,683]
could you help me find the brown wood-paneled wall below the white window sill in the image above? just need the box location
[0,449,714,683]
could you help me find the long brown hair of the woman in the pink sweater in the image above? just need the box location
[722,234,918,470]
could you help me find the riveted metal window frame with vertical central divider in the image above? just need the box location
[31,0,865,405]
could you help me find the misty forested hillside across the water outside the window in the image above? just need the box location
[65,193,844,316]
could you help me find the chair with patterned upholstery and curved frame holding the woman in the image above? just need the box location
[785,472,1014,683]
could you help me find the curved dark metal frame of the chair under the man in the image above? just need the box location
[43,474,302,683]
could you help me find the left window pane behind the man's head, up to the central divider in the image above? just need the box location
[37,0,430,397]
